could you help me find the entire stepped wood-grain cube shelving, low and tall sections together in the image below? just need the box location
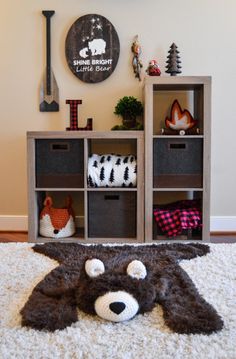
[27,76,211,243]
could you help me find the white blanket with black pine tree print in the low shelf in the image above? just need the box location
[88,154,137,187]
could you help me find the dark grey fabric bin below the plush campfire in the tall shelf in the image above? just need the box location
[153,136,203,187]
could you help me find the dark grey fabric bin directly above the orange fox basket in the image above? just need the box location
[36,139,84,188]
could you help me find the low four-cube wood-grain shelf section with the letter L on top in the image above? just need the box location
[27,131,144,243]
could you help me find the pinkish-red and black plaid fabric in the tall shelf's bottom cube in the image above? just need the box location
[154,200,202,237]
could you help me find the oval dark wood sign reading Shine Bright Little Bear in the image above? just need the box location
[66,14,120,83]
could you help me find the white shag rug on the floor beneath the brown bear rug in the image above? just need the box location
[0,243,236,359]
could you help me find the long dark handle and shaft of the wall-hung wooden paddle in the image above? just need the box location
[42,10,55,95]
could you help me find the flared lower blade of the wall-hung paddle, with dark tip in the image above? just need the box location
[39,71,59,112]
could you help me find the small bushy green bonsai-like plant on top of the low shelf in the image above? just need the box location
[112,96,143,130]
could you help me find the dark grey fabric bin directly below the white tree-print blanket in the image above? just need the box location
[88,191,137,238]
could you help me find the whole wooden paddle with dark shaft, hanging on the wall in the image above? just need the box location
[39,10,59,112]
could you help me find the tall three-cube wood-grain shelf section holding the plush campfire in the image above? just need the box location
[144,76,211,242]
